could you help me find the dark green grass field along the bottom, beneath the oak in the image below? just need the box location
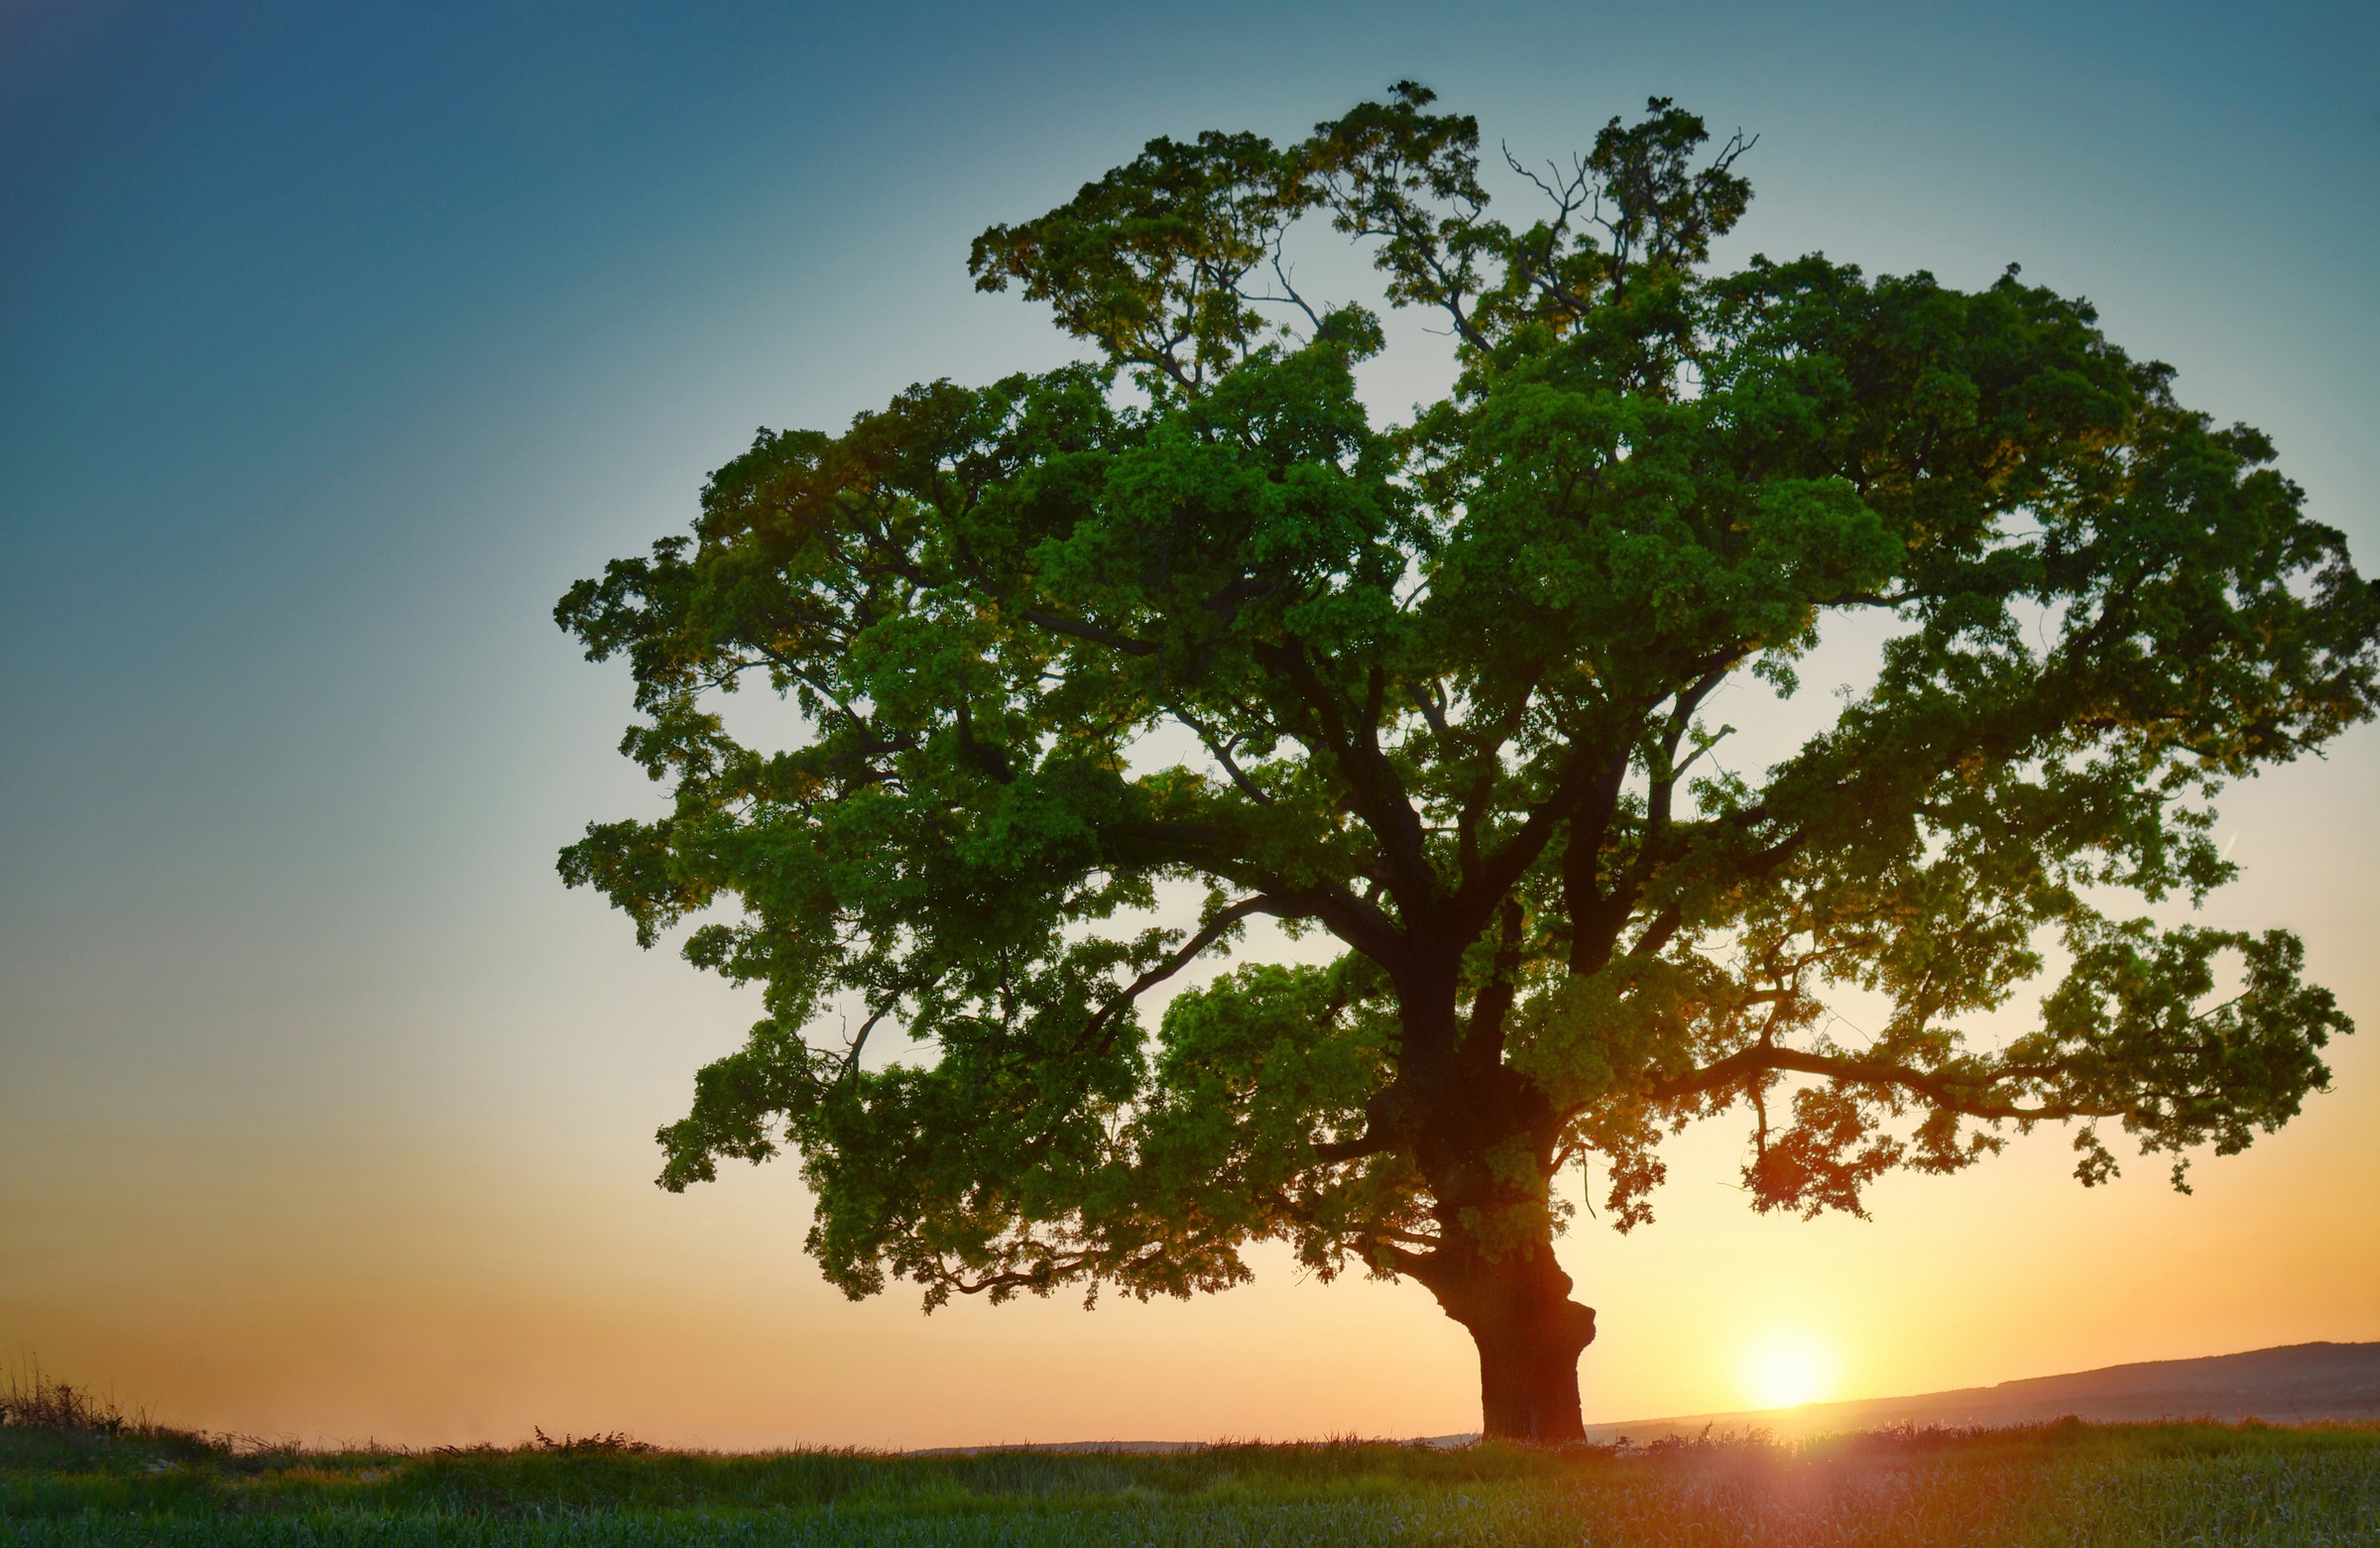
[0,1371,2380,1548]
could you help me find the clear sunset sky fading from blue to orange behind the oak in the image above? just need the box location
[0,0,2380,1448]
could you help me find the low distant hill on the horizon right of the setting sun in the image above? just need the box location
[1588,1343,2380,1441]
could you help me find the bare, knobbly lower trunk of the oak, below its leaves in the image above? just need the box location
[1423,1241,1595,1446]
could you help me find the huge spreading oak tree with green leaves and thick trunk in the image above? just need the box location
[557,83,2380,1441]
